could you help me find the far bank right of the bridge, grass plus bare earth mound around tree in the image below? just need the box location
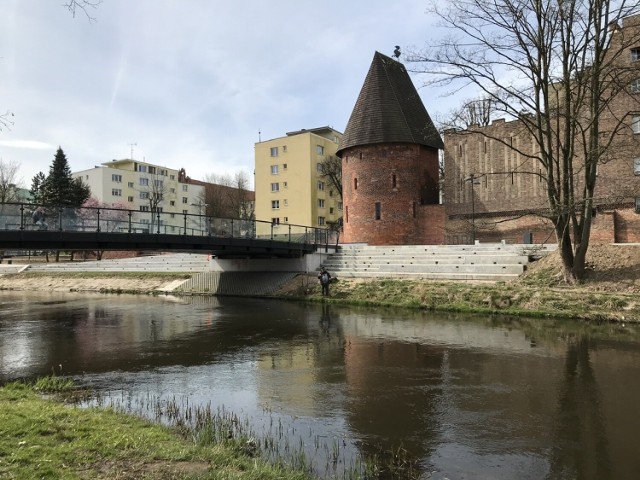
[274,245,640,323]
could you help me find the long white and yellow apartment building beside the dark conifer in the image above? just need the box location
[73,159,205,233]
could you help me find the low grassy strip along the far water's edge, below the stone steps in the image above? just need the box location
[276,276,640,322]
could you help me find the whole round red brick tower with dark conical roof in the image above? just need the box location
[336,52,444,245]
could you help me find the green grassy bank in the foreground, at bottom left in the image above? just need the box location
[0,380,309,480]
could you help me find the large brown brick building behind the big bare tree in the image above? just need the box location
[444,16,640,243]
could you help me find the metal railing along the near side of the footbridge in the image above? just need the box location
[0,203,330,247]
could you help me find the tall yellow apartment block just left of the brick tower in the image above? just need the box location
[255,127,342,235]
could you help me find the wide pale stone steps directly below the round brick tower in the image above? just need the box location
[323,243,554,281]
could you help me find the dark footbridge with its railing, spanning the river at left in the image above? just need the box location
[0,203,329,258]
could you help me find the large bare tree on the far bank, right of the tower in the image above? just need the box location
[411,0,640,282]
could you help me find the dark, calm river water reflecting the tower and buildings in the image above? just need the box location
[0,292,640,480]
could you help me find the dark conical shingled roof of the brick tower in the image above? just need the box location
[337,52,444,157]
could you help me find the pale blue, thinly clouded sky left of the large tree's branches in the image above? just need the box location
[0,0,453,188]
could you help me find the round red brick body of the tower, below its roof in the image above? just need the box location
[342,144,444,245]
